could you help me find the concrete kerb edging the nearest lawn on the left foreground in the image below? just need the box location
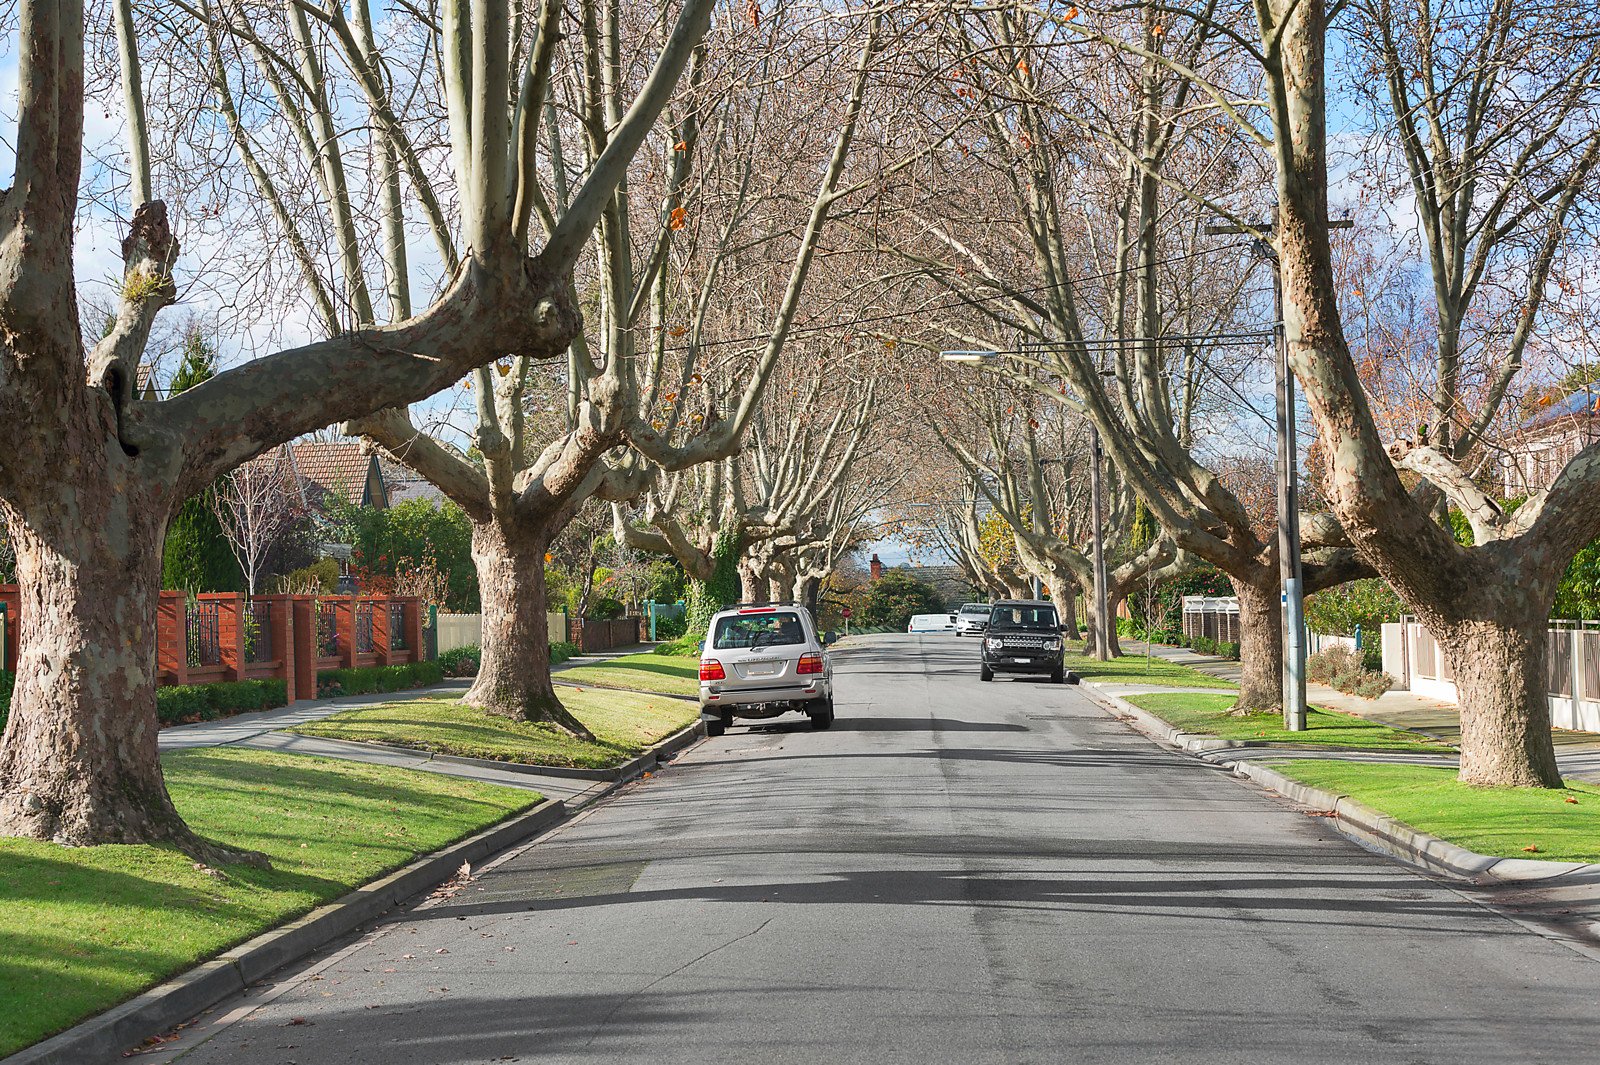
[0,800,568,1065]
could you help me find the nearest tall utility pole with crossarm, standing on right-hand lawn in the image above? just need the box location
[1205,219,1354,732]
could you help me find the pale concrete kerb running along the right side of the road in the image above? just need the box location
[1075,681,1600,889]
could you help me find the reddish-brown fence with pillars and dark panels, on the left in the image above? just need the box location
[0,585,422,702]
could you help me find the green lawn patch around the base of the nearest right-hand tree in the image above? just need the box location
[1272,760,1600,862]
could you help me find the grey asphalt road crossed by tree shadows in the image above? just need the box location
[168,636,1600,1065]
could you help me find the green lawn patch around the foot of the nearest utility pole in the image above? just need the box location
[1128,692,1454,755]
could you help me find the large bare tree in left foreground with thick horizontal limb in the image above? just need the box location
[0,0,712,860]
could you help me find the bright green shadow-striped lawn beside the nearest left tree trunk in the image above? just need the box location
[0,748,539,1057]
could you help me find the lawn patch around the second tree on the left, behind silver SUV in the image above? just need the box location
[291,688,699,769]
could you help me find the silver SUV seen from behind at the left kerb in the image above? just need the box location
[701,603,834,736]
